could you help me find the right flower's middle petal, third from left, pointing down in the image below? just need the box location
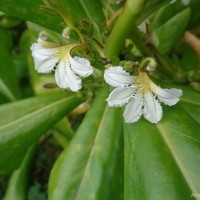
[124,93,143,123]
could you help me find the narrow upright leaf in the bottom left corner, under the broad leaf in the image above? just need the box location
[3,145,35,200]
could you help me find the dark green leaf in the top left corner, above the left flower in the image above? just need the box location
[0,0,62,32]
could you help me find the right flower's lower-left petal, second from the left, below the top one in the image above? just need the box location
[107,87,135,106]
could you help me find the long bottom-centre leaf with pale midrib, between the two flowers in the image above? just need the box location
[49,87,123,200]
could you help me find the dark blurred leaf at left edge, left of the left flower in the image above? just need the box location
[0,28,20,102]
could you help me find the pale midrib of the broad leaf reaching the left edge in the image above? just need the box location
[0,97,71,132]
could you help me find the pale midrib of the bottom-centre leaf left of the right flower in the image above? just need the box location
[74,106,108,200]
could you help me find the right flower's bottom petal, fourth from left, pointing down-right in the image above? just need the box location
[143,92,162,123]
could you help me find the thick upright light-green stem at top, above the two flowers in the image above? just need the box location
[105,0,145,58]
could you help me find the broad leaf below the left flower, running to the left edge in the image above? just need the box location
[0,92,81,174]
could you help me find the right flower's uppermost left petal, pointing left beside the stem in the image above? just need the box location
[104,66,133,87]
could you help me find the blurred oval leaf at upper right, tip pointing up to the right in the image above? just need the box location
[151,8,190,54]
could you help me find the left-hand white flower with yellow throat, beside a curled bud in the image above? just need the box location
[31,39,93,92]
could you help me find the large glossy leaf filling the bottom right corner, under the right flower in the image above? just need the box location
[124,86,200,200]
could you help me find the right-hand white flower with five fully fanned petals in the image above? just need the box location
[104,66,182,123]
